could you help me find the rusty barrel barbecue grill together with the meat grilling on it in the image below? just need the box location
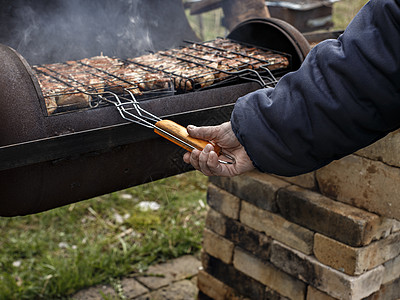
[0,14,309,216]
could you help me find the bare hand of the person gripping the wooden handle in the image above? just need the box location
[183,122,254,177]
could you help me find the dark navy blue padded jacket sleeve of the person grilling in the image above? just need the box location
[231,0,400,176]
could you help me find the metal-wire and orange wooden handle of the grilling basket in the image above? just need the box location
[97,90,236,164]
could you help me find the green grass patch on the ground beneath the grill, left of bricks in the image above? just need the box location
[0,172,207,299]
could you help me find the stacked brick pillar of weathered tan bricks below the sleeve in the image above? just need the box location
[198,132,400,300]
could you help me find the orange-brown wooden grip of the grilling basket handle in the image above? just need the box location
[154,120,221,155]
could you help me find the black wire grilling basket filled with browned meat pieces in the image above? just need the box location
[32,38,291,115]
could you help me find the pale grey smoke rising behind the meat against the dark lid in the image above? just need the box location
[0,0,195,64]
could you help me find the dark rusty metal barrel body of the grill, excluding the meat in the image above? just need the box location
[0,20,309,216]
